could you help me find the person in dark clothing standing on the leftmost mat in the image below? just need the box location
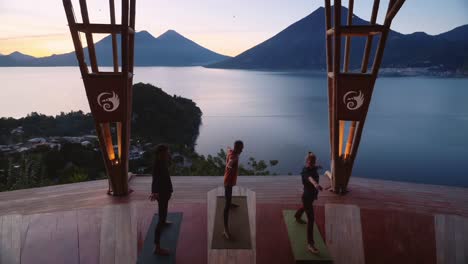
[149,144,173,255]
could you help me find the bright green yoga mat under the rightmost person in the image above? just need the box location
[283,210,333,263]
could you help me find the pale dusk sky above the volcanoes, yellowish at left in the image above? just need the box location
[0,0,468,57]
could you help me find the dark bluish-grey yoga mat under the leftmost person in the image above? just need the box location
[137,213,182,264]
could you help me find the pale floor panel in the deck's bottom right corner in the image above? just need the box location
[434,215,468,264]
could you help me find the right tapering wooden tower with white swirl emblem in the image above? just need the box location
[325,0,405,194]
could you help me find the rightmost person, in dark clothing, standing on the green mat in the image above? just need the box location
[296,152,323,254]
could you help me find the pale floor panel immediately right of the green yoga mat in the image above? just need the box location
[325,204,364,264]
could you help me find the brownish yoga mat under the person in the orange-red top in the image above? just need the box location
[211,196,252,249]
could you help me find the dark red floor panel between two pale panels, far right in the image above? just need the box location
[361,208,436,264]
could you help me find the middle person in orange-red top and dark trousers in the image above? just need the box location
[223,140,244,239]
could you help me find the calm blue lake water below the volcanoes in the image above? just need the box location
[0,67,468,187]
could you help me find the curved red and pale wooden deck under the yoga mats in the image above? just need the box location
[0,176,468,264]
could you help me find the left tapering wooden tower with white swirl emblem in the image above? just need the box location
[63,0,135,196]
